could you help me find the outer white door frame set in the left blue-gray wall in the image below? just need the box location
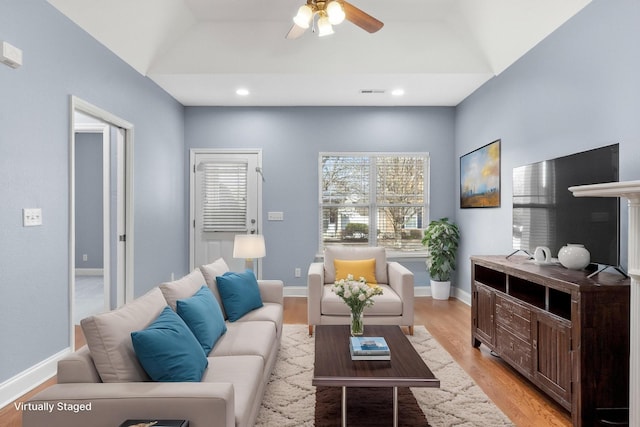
[69,95,134,348]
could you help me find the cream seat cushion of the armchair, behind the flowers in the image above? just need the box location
[320,285,402,316]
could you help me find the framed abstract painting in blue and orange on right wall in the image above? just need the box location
[460,139,500,208]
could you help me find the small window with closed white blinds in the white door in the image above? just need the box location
[201,160,248,232]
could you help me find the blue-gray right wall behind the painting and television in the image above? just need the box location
[456,0,640,292]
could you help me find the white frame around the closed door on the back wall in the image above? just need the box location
[189,148,264,271]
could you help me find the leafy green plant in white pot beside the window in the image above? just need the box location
[422,218,460,300]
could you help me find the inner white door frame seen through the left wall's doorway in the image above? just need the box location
[72,122,111,319]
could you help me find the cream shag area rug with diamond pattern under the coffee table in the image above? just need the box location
[256,325,514,427]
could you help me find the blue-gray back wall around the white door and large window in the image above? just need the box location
[185,107,456,286]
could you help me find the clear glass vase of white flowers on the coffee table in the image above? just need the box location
[331,274,382,336]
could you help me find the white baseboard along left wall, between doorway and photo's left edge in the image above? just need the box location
[0,347,71,408]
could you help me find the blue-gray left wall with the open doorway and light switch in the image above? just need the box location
[0,0,189,383]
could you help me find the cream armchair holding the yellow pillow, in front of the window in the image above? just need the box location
[307,246,414,335]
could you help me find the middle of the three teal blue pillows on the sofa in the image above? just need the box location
[176,285,227,354]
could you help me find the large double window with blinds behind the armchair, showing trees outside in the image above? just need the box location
[319,153,429,252]
